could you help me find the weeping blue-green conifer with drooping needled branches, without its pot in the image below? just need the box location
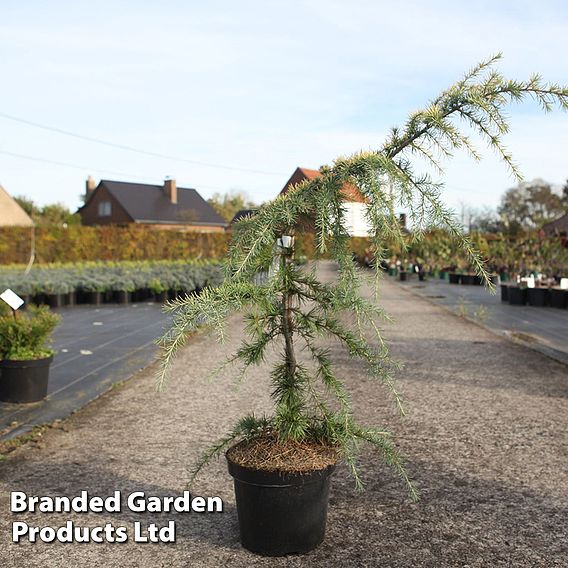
[158,54,568,498]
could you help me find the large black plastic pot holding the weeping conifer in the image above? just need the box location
[227,458,335,556]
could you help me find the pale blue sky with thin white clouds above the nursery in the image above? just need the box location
[0,0,568,213]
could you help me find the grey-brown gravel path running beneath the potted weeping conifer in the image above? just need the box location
[0,267,568,568]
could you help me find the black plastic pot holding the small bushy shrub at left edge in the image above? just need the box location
[0,356,53,403]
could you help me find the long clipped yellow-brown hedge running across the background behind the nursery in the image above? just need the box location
[0,225,568,274]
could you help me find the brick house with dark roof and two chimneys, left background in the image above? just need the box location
[78,176,227,232]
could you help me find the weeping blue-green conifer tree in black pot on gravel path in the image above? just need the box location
[158,56,568,555]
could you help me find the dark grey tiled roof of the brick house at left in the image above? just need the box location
[87,179,227,226]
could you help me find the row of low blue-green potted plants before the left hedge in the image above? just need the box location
[0,260,223,307]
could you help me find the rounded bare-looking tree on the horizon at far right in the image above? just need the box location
[497,179,566,234]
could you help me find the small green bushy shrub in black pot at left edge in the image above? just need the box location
[0,305,60,403]
